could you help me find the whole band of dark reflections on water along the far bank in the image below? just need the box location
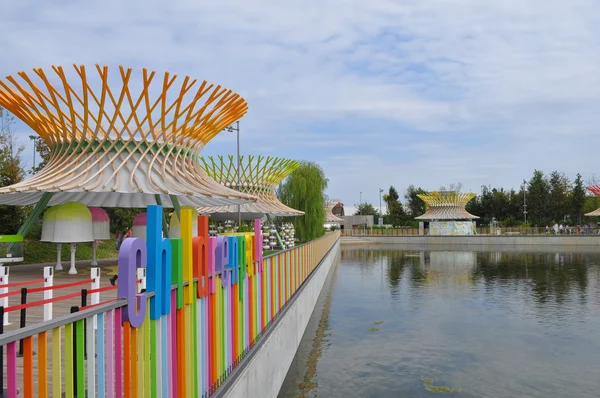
[342,248,600,304]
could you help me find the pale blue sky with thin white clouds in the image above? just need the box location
[0,0,600,207]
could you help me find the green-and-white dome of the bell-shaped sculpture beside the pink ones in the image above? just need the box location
[52,202,94,243]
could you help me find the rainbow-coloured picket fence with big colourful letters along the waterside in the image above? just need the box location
[0,206,340,398]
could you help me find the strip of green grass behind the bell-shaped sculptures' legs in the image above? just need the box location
[23,238,119,264]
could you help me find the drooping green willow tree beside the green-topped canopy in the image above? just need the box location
[277,162,328,242]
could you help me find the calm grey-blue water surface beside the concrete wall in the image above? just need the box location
[280,245,600,398]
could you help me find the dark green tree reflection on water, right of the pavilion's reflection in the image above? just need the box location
[473,252,600,304]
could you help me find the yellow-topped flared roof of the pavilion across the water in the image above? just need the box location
[415,191,479,221]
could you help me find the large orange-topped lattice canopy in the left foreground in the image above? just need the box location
[0,65,255,207]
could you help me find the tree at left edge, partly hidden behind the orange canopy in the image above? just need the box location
[0,108,25,234]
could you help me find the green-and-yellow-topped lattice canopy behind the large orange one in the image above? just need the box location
[198,155,304,220]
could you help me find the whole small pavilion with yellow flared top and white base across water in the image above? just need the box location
[415,191,479,235]
